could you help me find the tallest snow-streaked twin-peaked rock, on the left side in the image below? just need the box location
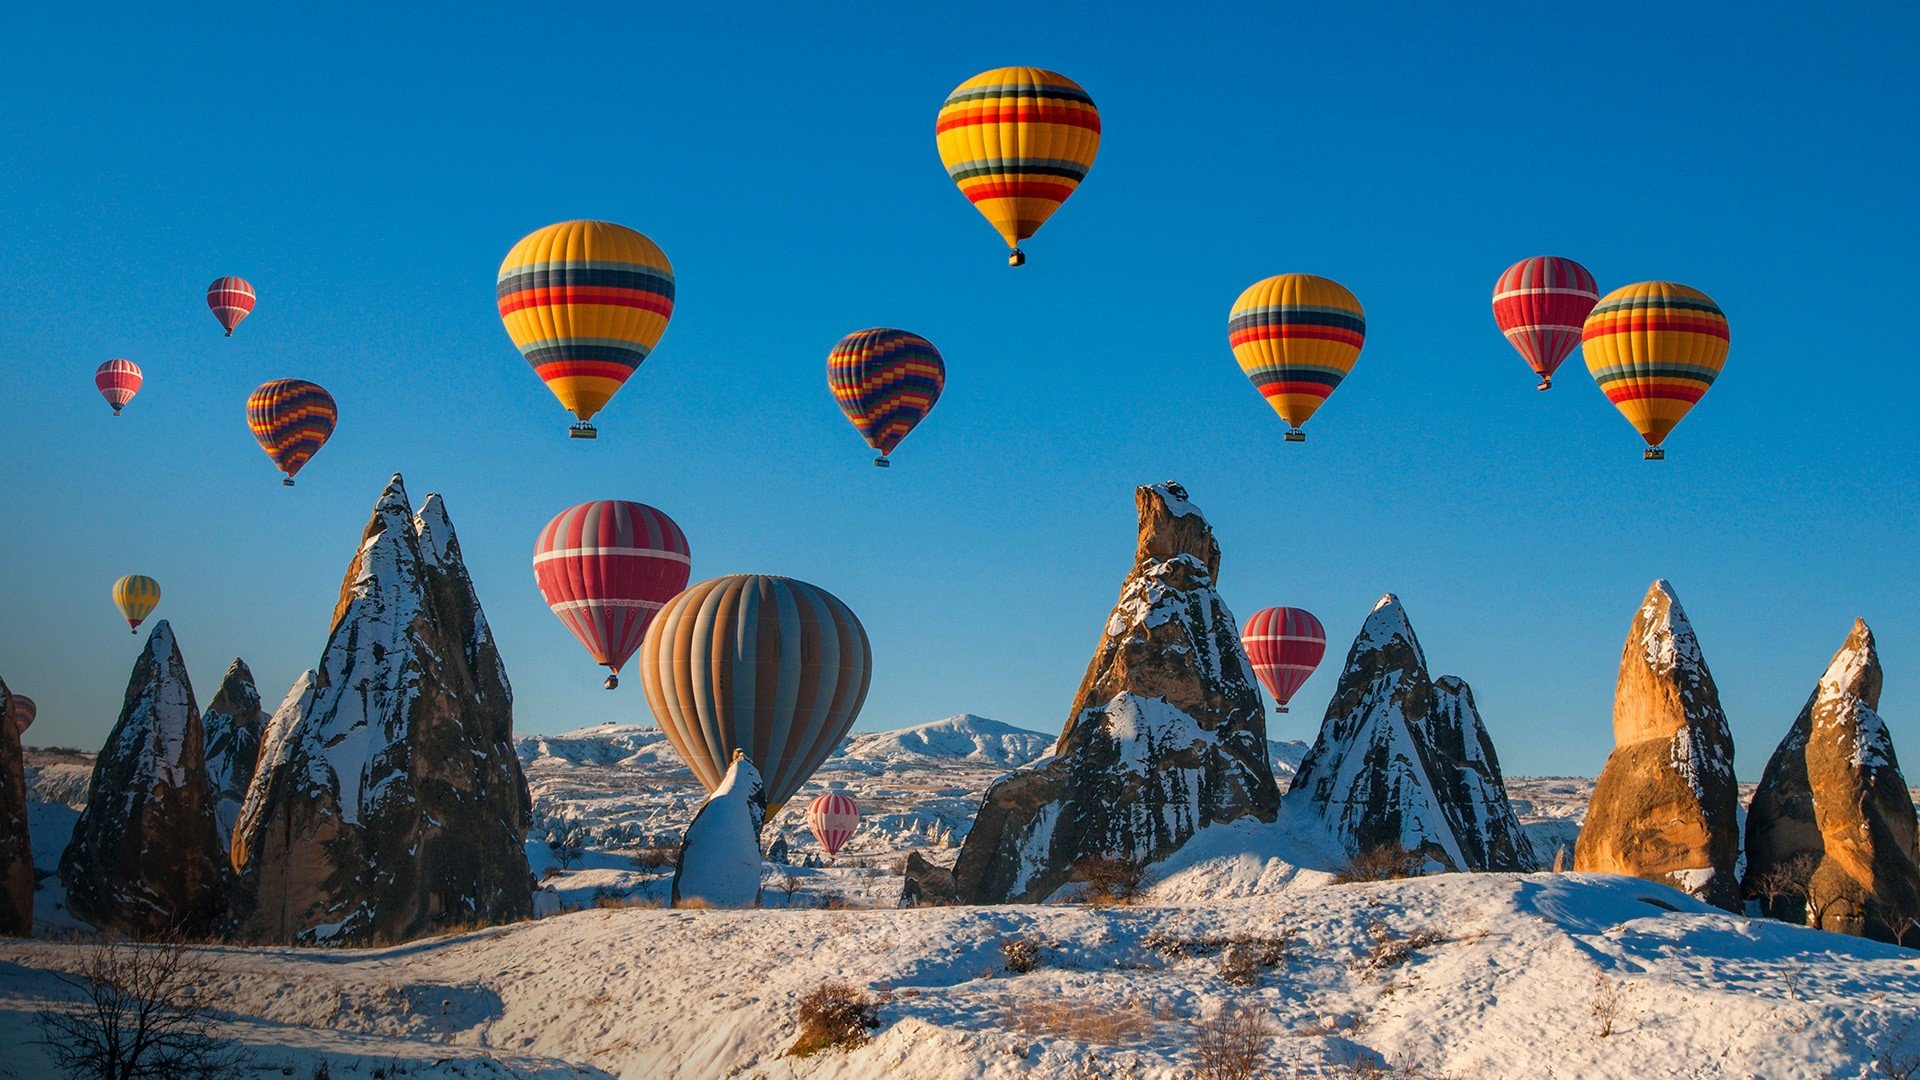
[232,475,532,942]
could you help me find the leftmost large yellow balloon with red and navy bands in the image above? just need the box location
[497,221,674,438]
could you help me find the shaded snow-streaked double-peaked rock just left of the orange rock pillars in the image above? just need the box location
[1286,594,1536,871]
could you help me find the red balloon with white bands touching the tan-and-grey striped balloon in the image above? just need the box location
[534,500,691,690]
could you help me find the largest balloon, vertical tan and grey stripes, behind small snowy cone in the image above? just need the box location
[639,575,874,807]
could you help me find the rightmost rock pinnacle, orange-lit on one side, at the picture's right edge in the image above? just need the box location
[1745,621,1920,942]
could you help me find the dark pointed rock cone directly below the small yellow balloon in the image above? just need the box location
[60,619,227,936]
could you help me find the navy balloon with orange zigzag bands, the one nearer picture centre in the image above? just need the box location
[828,329,947,469]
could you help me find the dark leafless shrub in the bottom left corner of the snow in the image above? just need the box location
[40,938,250,1080]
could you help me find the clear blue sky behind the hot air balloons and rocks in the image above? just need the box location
[0,4,1920,778]
